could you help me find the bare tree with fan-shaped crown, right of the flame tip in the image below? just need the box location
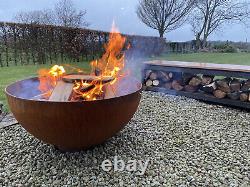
[136,0,195,37]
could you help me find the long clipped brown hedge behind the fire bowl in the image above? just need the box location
[0,22,165,67]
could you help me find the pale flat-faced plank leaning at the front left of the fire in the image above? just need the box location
[49,81,74,102]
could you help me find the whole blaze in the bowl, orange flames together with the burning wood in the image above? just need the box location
[39,25,126,101]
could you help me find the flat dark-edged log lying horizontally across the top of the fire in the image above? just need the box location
[62,75,114,83]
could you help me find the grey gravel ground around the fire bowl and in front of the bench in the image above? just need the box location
[0,92,250,186]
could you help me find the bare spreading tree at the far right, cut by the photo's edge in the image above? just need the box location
[190,0,250,49]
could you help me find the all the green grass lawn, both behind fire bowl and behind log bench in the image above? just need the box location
[0,53,250,110]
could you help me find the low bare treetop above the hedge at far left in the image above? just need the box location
[14,9,55,25]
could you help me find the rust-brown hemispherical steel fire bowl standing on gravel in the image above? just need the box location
[5,78,142,151]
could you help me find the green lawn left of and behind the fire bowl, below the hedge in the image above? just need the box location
[0,62,89,111]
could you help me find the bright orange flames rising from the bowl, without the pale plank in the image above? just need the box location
[39,24,126,101]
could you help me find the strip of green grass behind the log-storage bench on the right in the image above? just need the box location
[157,53,250,66]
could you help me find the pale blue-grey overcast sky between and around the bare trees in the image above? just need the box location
[0,0,250,41]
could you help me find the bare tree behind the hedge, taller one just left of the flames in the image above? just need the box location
[55,0,89,27]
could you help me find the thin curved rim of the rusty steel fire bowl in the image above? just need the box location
[4,76,143,103]
